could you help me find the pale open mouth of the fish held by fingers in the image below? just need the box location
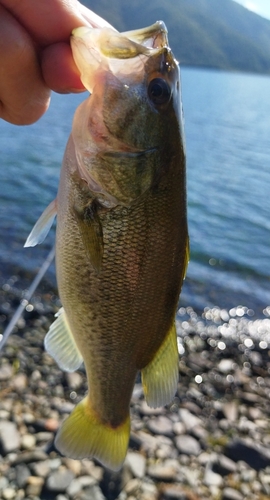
[71,21,170,93]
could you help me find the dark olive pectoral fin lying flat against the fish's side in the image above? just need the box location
[74,201,103,272]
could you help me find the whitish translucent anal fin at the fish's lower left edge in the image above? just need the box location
[44,307,83,372]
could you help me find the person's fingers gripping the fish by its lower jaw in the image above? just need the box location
[0,0,113,125]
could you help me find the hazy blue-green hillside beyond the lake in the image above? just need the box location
[83,0,270,74]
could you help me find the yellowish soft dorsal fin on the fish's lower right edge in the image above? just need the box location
[141,324,179,408]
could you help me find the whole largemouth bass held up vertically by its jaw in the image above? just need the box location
[26,22,188,470]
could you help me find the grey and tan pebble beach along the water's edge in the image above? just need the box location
[0,280,270,500]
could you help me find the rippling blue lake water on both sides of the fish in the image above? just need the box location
[0,68,270,315]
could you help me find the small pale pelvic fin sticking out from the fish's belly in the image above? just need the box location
[24,199,57,247]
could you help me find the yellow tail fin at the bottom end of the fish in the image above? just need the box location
[55,397,130,470]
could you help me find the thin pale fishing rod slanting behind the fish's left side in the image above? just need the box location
[0,247,55,351]
